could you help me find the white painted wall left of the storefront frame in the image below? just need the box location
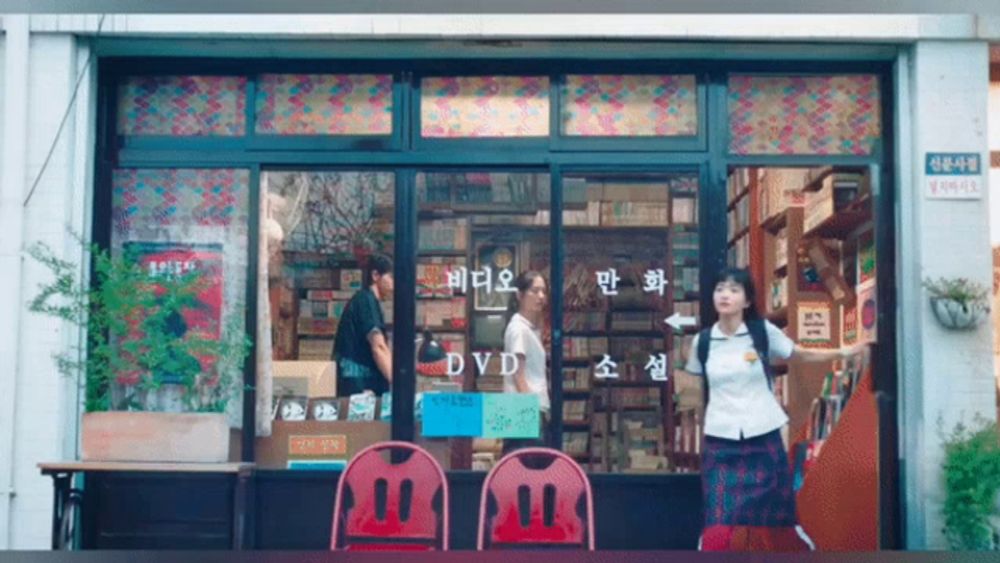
[0,25,93,549]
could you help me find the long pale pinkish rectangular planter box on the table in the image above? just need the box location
[80,411,229,463]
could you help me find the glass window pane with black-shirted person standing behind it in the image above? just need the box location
[256,170,395,468]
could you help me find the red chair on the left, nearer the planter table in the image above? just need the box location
[330,442,448,551]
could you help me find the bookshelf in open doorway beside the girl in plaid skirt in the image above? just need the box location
[730,167,877,520]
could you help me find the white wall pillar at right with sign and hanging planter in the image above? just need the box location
[898,41,996,549]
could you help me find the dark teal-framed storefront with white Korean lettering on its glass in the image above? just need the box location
[3,13,988,550]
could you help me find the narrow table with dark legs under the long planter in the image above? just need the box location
[38,461,254,550]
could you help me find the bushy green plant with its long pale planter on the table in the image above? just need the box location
[28,243,250,462]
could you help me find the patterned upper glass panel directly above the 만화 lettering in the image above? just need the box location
[562,75,698,137]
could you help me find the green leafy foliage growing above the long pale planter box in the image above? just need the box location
[28,243,250,412]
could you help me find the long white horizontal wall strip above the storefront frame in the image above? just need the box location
[17,14,1000,42]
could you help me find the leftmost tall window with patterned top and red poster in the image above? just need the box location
[108,169,249,427]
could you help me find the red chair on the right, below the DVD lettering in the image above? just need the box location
[477,448,594,551]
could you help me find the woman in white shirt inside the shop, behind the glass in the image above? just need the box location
[503,271,550,451]
